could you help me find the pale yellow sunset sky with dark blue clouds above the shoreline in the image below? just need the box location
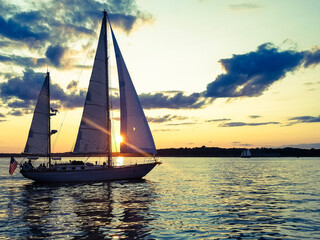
[0,0,320,153]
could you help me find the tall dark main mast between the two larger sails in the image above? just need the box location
[103,10,112,167]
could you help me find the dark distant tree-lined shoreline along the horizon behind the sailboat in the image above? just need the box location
[0,146,320,157]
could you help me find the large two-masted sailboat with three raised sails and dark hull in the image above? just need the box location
[20,11,161,182]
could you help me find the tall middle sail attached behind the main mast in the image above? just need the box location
[74,18,107,153]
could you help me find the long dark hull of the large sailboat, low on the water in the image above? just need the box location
[20,162,160,183]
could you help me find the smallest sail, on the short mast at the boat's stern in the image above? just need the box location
[24,75,50,155]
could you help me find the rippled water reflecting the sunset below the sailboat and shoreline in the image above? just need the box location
[0,158,320,239]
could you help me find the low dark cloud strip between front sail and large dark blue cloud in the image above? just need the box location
[139,92,211,109]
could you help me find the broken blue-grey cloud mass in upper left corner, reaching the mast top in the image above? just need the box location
[0,0,152,71]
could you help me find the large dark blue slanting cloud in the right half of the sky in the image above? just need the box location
[205,43,305,98]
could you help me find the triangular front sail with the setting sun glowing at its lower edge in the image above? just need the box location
[110,27,157,154]
